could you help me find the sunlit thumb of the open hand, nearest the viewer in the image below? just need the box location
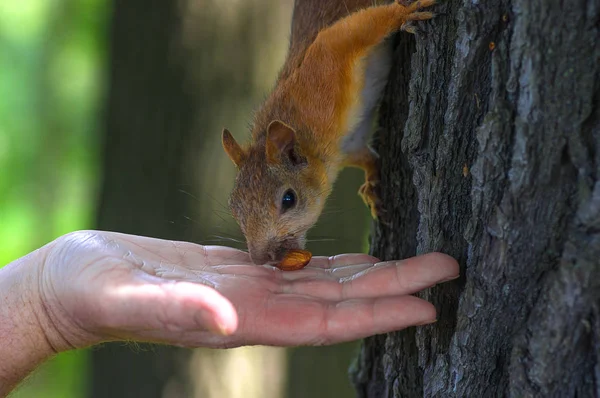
[93,276,238,339]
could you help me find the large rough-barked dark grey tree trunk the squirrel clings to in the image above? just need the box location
[352,0,600,398]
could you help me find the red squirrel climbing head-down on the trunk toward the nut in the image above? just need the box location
[222,0,435,264]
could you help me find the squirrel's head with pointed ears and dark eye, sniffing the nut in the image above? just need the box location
[222,120,330,264]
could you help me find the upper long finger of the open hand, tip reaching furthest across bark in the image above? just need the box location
[281,253,459,300]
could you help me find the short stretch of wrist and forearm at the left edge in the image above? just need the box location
[0,248,55,397]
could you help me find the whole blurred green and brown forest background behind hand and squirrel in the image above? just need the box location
[0,0,369,398]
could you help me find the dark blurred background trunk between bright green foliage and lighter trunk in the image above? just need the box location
[90,0,195,398]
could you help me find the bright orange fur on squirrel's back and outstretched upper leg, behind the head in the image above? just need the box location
[252,4,428,165]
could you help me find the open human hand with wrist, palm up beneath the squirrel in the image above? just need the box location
[0,231,459,396]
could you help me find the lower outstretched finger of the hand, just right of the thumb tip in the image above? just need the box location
[230,296,436,346]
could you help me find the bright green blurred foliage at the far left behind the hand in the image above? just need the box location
[0,0,108,398]
